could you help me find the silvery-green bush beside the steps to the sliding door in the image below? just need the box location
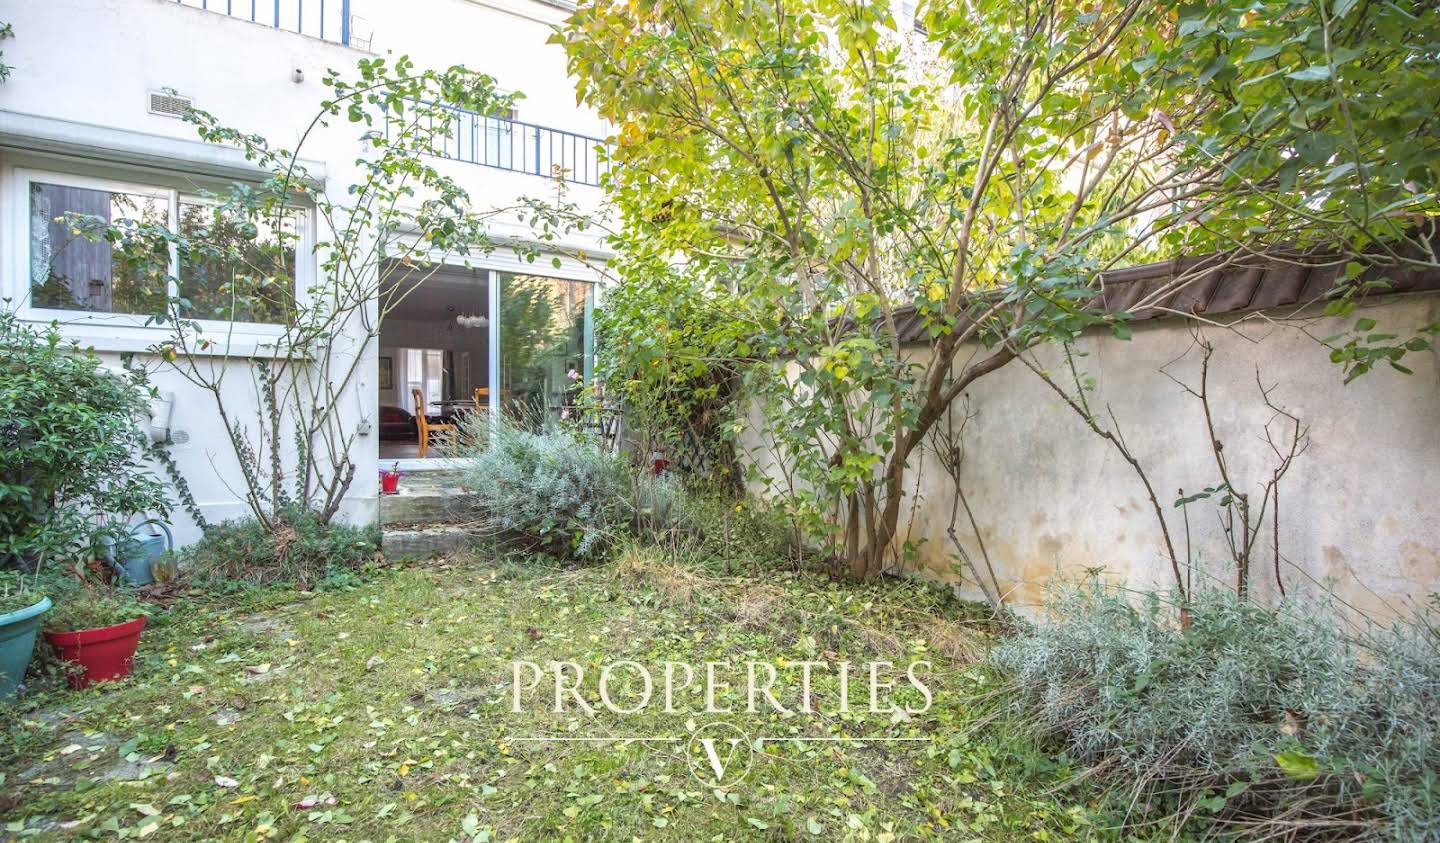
[462,419,638,561]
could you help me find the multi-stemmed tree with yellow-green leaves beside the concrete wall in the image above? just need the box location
[557,0,1437,585]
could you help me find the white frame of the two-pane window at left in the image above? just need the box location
[0,161,318,342]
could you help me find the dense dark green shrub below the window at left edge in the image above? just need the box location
[0,311,168,566]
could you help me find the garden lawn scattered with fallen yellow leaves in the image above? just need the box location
[0,550,1099,840]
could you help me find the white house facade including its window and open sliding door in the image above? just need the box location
[0,0,609,542]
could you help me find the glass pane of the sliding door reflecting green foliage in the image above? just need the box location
[500,272,590,421]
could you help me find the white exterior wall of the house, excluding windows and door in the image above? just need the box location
[0,0,608,543]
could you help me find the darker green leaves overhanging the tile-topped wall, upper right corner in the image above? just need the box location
[1146,0,1440,382]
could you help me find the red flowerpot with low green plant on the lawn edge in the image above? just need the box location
[45,582,148,689]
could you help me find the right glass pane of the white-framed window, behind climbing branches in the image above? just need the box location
[180,200,302,324]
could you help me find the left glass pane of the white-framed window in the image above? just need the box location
[30,182,170,316]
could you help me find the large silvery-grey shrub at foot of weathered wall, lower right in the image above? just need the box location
[992,581,1440,840]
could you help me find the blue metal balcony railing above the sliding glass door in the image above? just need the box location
[420,105,609,184]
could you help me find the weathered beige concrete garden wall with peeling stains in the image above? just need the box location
[744,295,1440,615]
